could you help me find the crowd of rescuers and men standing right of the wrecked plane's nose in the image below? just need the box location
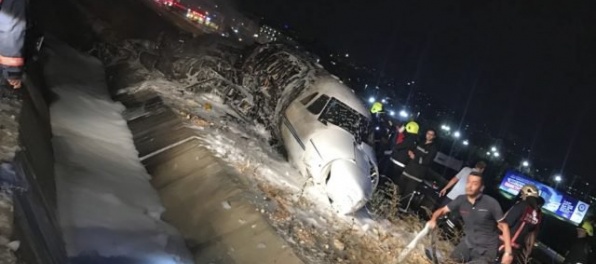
[371,104,596,264]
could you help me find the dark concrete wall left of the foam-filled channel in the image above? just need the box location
[13,60,66,264]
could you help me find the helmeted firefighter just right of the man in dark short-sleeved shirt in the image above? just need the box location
[499,184,544,264]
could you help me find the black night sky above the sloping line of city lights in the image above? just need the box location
[237,0,596,182]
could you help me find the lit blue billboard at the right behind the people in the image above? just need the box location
[499,171,590,224]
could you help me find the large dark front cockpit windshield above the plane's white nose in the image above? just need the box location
[319,98,371,143]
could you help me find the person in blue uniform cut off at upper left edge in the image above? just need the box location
[0,0,27,89]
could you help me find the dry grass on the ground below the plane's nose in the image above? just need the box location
[234,166,464,264]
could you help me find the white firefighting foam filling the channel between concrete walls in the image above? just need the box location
[44,38,192,263]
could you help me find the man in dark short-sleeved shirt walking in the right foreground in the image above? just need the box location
[428,172,513,264]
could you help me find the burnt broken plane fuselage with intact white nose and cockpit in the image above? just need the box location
[133,36,379,214]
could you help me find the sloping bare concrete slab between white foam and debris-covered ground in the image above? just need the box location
[119,91,302,264]
